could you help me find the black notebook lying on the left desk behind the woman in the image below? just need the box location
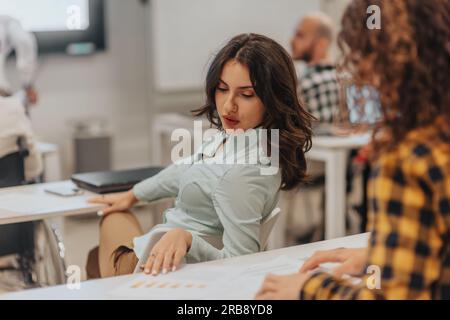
[71,167,164,193]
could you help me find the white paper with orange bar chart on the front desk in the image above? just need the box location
[110,256,302,300]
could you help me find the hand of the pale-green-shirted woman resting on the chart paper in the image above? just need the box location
[144,228,192,276]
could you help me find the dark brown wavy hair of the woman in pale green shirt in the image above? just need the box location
[193,33,313,190]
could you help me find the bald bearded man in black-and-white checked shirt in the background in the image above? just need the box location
[291,13,340,123]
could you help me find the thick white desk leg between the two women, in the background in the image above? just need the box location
[325,149,347,239]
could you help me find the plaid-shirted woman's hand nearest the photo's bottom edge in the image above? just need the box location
[255,273,310,300]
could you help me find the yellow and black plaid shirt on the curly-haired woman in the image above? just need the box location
[300,124,450,299]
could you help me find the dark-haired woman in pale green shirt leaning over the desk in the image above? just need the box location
[87,34,312,277]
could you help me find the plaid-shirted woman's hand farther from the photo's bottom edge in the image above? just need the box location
[300,248,367,279]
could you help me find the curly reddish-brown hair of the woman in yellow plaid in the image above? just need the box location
[338,0,450,156]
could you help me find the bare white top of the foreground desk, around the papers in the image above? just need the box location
[0,233,369,300]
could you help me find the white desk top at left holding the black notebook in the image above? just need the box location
[0,180,104,225]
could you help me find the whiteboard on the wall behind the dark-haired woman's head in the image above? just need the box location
[150,0,321,91]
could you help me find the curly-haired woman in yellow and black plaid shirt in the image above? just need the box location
[257,0,450,299]
